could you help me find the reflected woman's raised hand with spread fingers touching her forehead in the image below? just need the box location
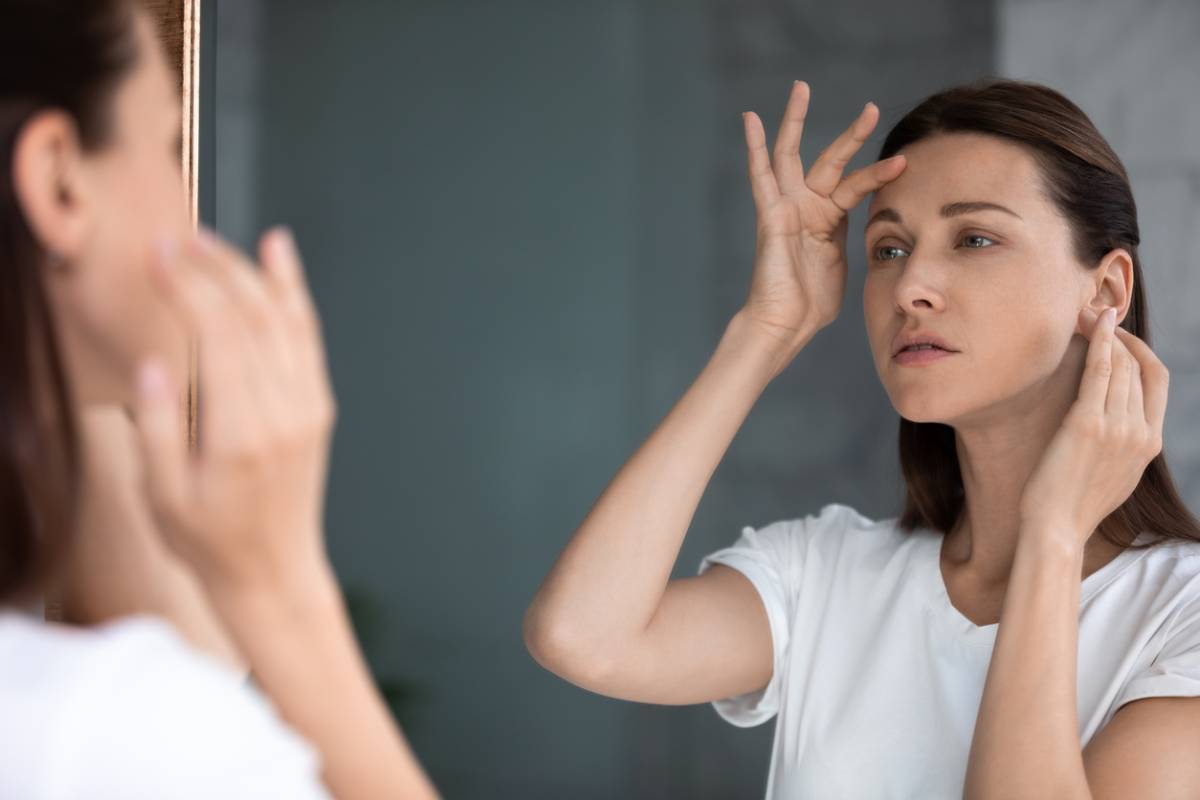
[743,80,905,357]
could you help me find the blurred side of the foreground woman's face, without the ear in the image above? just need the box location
[46,13,191,403]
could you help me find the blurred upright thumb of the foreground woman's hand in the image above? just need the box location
[133,360,187,516]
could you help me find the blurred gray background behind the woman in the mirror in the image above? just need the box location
[202,0,1200,799]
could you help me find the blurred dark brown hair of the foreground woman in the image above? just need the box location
[0,0,138,603]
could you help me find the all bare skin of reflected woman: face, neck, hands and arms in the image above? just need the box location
[526,82,1200,798]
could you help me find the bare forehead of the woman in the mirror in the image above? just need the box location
[869,133,1045,219]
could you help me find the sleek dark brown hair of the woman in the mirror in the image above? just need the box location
[880,79,1200,547]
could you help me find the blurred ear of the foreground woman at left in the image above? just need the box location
[12,110,88,258]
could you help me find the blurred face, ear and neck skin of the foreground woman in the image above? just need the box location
[14,0,234,669]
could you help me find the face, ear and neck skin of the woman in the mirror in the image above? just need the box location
[863,133,1133,624]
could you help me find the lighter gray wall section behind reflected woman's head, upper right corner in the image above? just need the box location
[998,0,1200,503]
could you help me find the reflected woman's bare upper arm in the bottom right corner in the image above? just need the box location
[1084,697,1200,800]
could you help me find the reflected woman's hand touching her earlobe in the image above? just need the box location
[1020,307,1168,549]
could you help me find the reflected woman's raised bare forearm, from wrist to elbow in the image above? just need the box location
[526,314,806,660]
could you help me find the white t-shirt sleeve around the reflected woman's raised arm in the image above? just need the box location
[700,519,805,728]
